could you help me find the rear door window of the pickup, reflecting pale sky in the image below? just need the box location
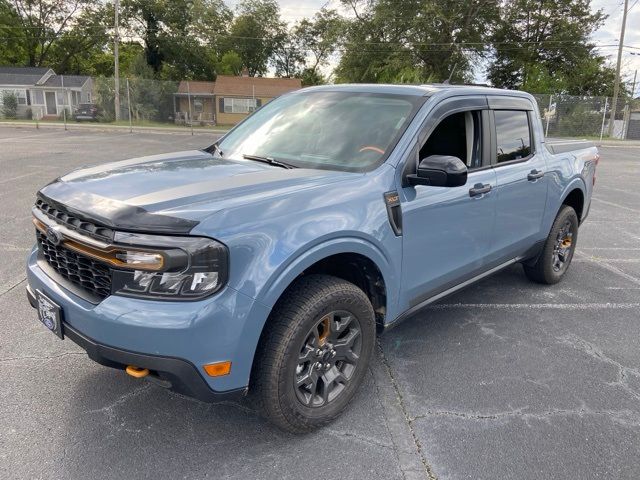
[494,110,531,163]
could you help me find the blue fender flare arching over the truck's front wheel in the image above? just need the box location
[256,237,399,314]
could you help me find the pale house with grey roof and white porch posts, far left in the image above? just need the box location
[0,66,93,119]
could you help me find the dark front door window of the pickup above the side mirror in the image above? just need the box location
[420,110,482,170]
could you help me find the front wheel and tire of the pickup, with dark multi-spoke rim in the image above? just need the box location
[250,275,376,433]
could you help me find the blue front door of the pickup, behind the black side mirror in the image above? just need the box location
[400,97,497,308]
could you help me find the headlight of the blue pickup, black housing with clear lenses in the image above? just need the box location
[112,232,229,300]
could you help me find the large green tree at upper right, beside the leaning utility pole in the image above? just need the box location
[488,0,615,95]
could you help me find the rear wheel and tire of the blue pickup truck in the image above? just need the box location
[522,205,579,285]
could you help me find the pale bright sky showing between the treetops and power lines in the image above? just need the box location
[228,0,640,93]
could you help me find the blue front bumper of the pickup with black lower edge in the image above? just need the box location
[27,248,270,401]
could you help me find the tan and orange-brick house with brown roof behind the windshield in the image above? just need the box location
[174,75,302,125]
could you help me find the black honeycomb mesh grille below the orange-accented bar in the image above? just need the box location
[36,230,111,300]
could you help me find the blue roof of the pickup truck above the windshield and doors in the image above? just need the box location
[302,83,531,99]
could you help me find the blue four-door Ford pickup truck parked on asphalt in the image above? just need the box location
[27,85,599,432]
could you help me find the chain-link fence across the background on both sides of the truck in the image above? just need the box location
[0,75,640,140]
